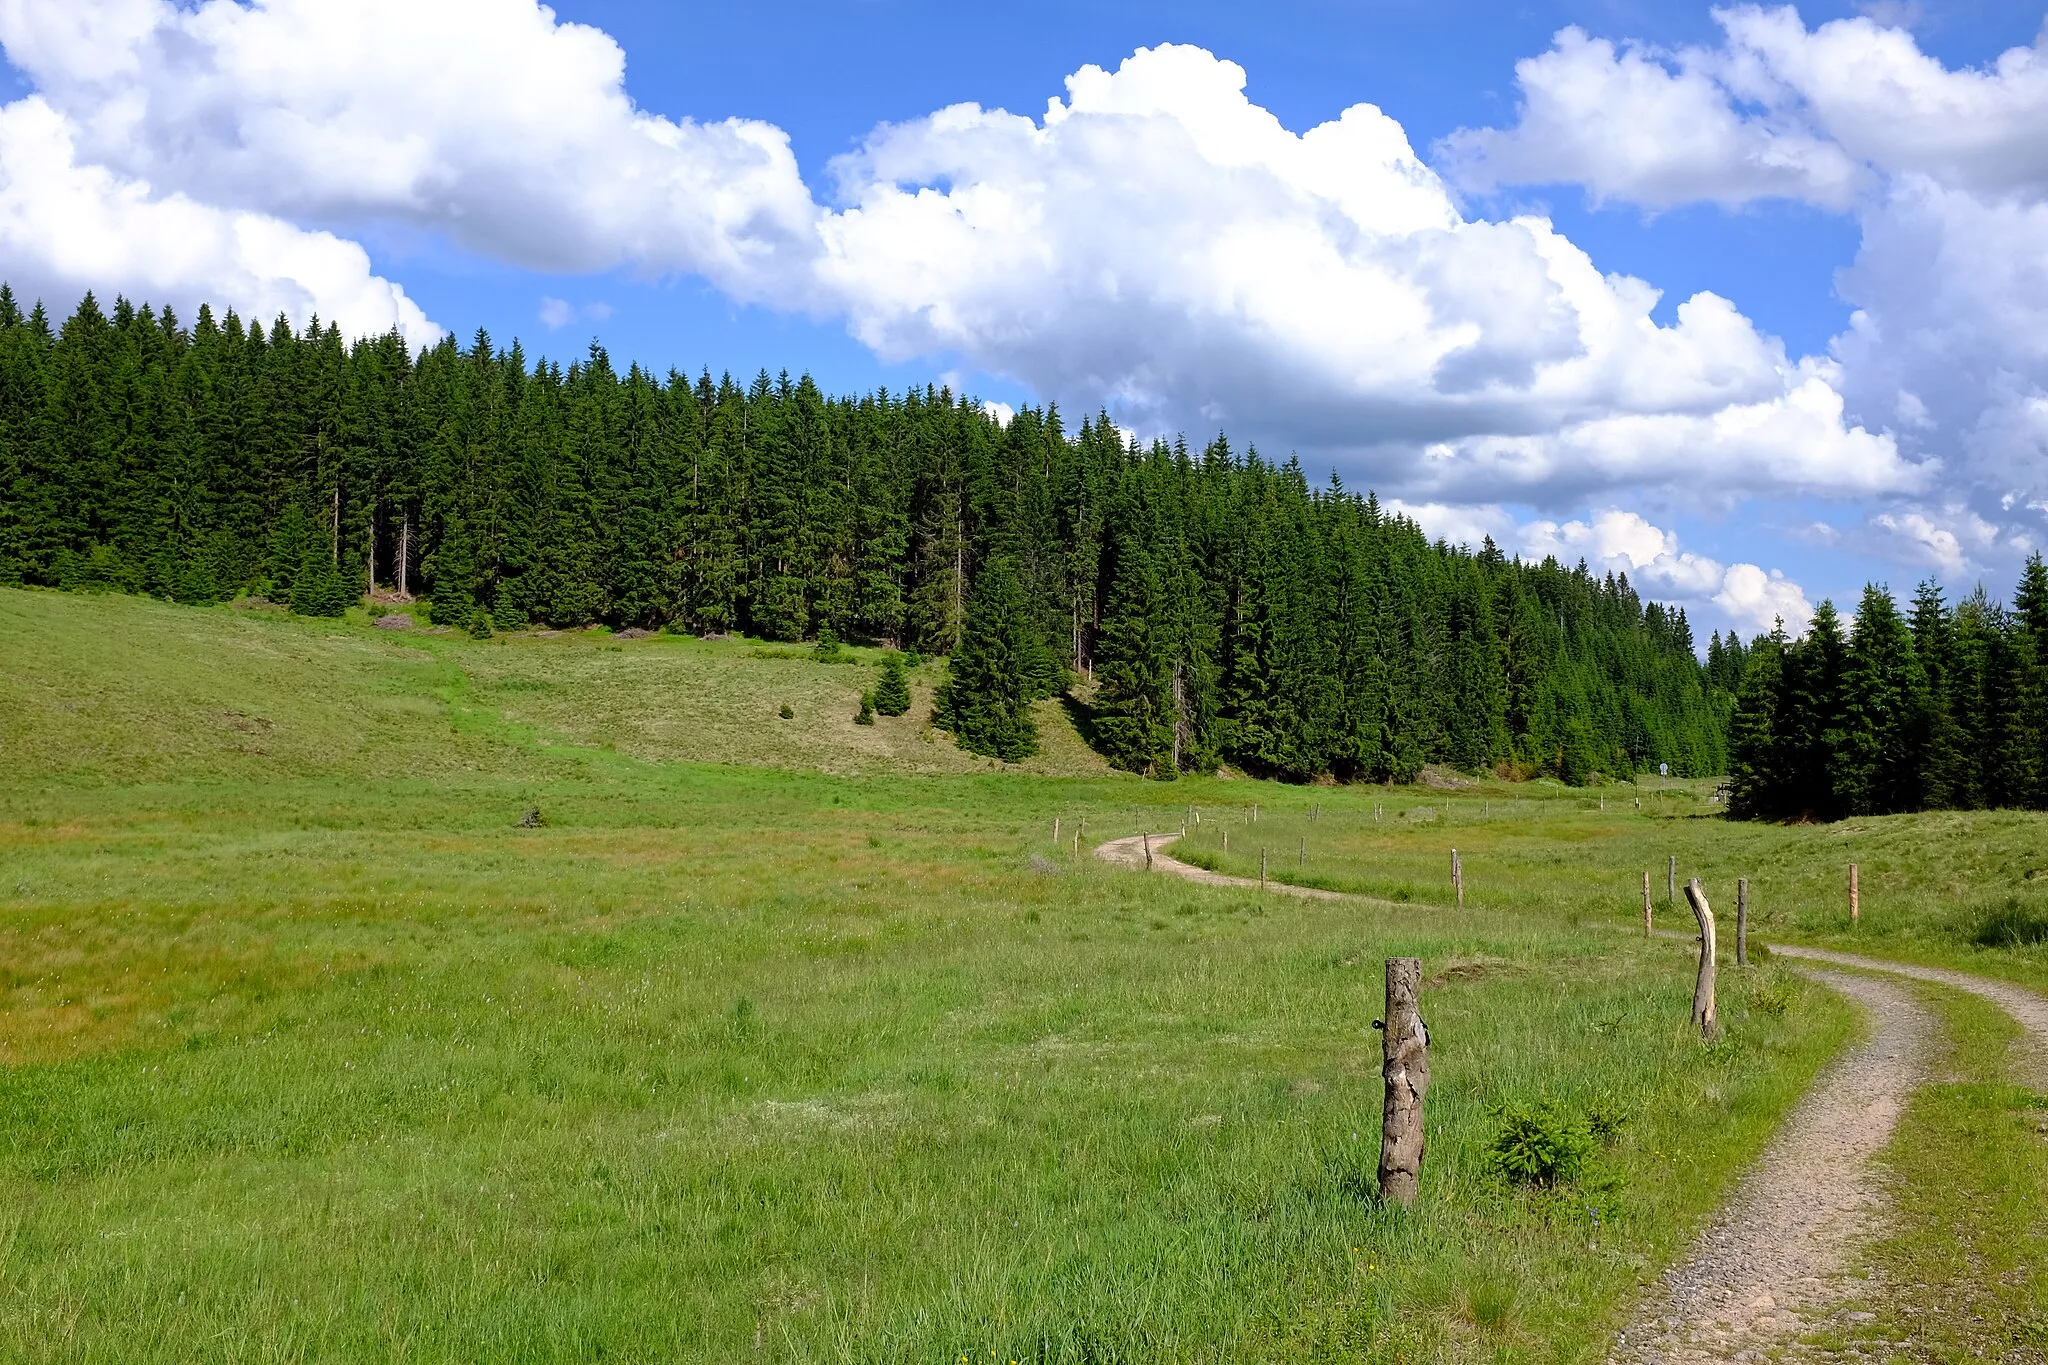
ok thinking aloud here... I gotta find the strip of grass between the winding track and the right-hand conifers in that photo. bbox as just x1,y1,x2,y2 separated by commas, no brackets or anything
1174,778,2048,988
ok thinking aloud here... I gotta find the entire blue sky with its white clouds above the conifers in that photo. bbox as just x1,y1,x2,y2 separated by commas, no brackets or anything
0,0,2048,632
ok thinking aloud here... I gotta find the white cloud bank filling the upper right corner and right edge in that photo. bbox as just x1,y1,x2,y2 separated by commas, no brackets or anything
1438,6,2048,575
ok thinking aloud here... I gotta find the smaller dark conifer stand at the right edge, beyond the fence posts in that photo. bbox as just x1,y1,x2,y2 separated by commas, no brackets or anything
1731,568,2048,821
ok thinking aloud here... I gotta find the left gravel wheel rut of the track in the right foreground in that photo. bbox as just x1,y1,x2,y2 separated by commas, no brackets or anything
1610,968,1935,1365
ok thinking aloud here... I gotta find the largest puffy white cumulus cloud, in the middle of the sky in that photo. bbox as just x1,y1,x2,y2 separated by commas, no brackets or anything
819,47,1900,499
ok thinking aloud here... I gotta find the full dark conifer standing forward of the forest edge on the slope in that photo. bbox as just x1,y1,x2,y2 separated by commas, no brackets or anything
934,559,1038,763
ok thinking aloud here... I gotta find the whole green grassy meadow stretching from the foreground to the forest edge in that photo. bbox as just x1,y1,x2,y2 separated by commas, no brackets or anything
0,589,2048,1363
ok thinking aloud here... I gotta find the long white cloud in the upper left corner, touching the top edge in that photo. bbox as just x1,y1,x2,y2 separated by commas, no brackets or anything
0,0,817,305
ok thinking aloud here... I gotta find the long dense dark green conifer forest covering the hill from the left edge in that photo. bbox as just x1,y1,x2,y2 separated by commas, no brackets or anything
0,291,1741,782
